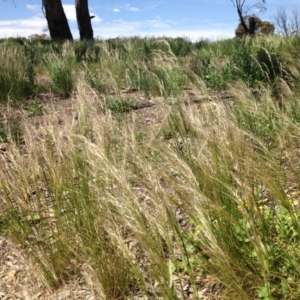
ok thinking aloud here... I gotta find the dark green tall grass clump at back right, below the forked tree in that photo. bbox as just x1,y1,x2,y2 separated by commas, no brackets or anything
191,37,299,94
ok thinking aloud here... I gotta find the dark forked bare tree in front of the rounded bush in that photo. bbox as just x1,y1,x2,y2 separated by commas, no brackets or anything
231,0,266,35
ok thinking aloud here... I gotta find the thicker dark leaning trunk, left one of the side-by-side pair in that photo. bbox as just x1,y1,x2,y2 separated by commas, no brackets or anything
43,0,73,40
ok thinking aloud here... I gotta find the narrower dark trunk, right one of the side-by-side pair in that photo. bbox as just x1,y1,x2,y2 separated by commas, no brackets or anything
76,0,94,40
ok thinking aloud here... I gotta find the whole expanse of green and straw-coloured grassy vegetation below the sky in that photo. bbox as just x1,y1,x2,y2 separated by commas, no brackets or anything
0,36,300,300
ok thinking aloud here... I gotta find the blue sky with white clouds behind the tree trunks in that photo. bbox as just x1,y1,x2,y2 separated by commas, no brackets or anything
0,0,300,41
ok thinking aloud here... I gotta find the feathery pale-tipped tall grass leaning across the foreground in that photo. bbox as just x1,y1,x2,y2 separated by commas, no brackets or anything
1,78,299,299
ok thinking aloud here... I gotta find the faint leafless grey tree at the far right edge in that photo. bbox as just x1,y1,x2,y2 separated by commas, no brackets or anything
273,7,300,36
